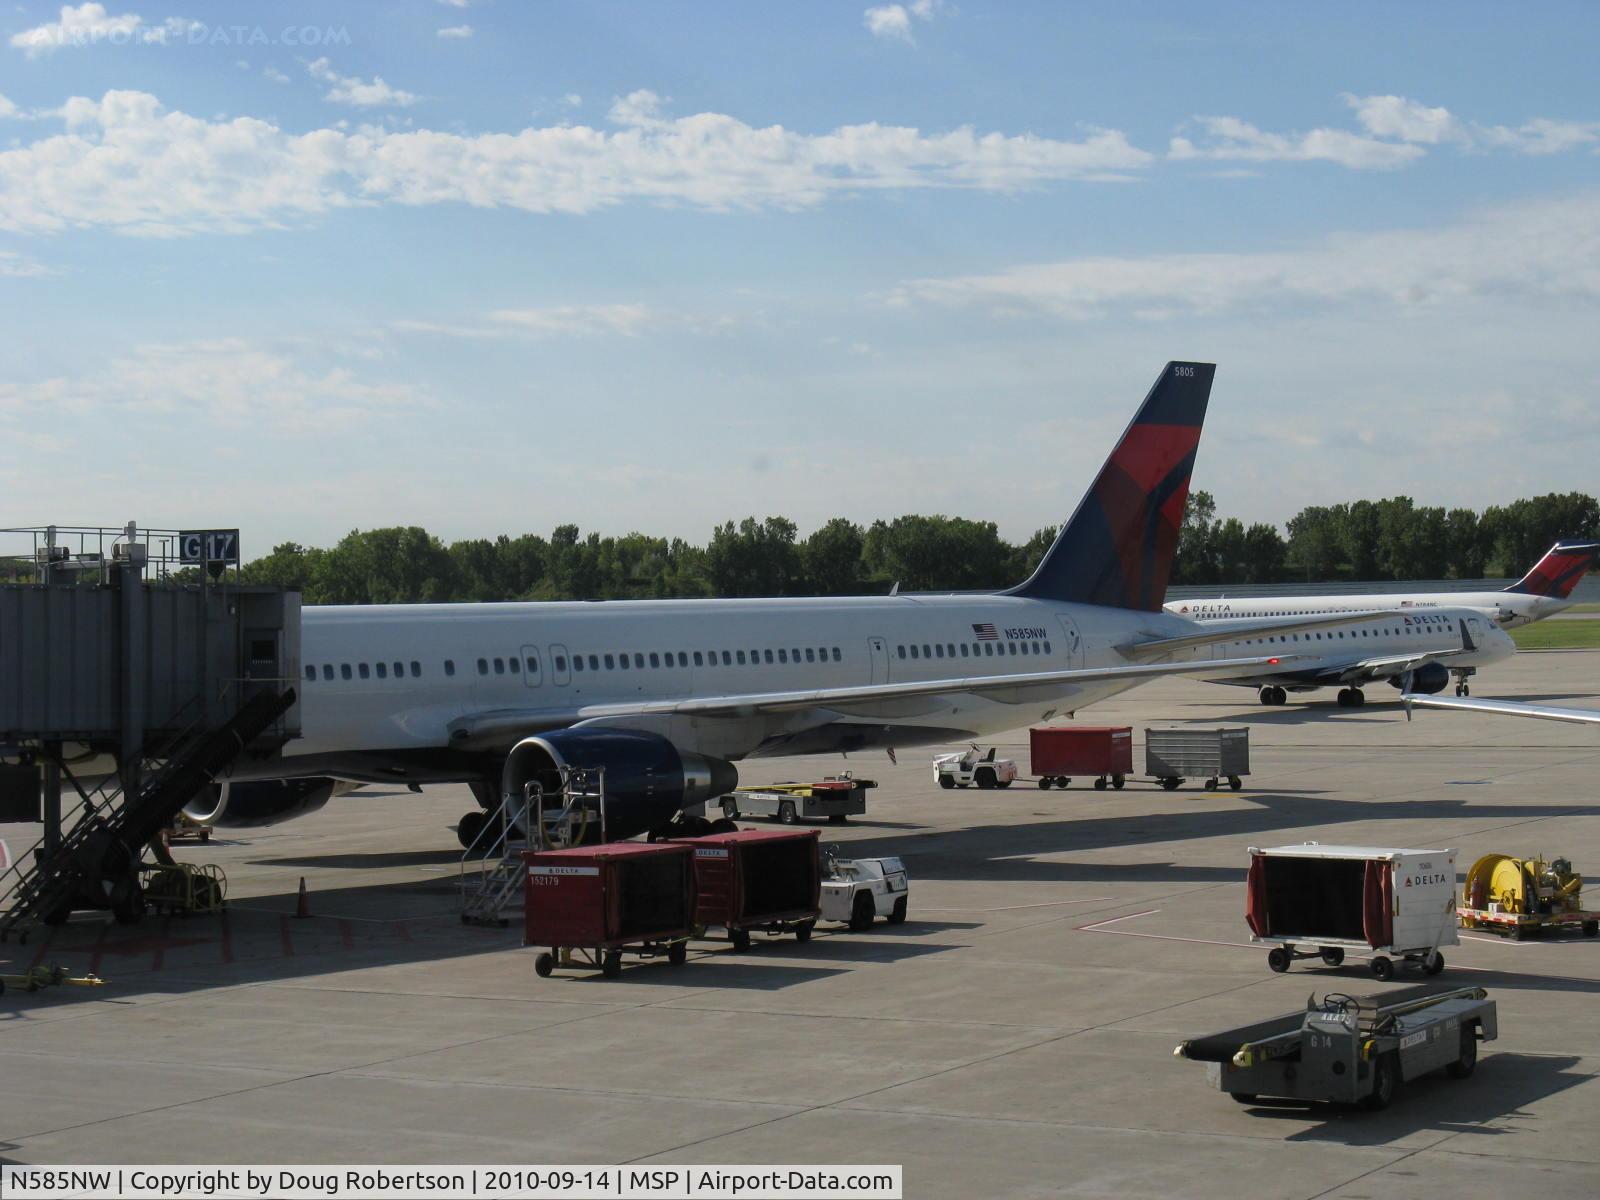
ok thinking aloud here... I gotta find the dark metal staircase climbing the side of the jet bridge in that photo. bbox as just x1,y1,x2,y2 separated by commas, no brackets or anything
0,688,294,942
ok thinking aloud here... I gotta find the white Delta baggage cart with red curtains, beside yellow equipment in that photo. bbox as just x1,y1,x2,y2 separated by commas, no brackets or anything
1245,842,1461,979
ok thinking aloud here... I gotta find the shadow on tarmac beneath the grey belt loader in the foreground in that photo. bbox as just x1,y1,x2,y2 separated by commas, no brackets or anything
1250,1045,1592,1154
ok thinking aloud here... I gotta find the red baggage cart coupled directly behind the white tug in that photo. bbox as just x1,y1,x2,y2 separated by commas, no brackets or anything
688,829,822,952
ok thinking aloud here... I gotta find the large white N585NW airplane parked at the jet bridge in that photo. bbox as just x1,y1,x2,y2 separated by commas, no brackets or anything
186,362,1465,845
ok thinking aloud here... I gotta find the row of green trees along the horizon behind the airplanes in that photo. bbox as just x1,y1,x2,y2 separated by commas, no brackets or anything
240,491,1600,605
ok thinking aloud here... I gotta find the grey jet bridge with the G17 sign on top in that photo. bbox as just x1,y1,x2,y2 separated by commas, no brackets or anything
0,525,301,939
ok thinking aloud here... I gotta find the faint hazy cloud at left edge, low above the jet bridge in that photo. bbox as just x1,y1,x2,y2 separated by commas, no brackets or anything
0,338,432,435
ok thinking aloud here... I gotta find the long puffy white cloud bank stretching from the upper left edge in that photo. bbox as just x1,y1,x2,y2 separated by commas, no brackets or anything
0,87,1150,237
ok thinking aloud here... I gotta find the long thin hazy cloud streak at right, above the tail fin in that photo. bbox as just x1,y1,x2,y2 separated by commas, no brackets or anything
890,192,1600,320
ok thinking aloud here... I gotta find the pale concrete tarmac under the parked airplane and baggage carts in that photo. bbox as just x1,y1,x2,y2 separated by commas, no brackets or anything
0,651,1600,1200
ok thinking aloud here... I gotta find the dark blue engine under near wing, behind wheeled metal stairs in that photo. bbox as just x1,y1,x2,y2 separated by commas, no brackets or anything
501,726,739,840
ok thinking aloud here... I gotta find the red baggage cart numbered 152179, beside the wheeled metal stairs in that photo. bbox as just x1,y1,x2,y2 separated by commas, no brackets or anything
522,842,694,978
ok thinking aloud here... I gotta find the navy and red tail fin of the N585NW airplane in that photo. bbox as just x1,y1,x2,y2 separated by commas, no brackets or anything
1006,363,1216,613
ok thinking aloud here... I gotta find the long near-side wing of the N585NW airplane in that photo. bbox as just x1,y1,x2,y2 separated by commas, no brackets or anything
450,656,1288,746
